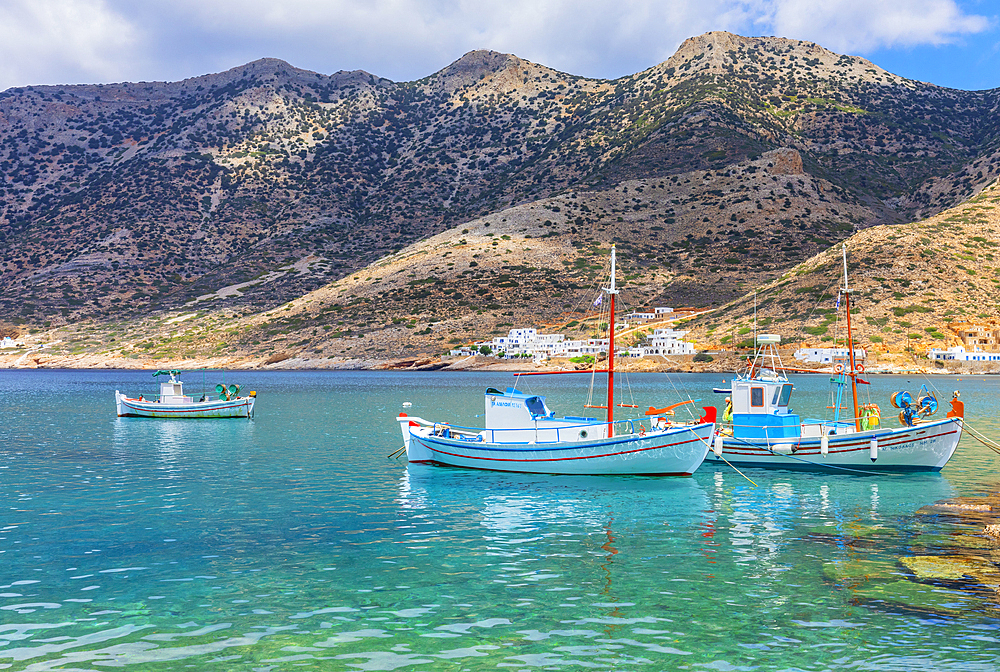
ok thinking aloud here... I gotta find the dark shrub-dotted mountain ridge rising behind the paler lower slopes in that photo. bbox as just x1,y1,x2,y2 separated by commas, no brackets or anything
0,33,1000,364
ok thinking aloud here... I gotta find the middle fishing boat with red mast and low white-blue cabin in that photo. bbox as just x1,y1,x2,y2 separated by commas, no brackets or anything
397,247,716,476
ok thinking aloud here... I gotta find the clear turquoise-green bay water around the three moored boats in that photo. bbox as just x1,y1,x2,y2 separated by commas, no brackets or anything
0,371,1000,670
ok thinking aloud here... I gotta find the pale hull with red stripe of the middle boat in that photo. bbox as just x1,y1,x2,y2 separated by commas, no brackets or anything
404,423,715,476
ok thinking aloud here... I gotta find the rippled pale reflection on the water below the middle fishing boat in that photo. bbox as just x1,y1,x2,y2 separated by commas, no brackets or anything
397,464,715,600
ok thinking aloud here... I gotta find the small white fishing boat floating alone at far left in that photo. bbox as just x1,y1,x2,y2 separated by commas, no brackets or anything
115,370,257,418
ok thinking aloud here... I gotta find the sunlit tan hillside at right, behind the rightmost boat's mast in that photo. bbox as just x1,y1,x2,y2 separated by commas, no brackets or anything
690,177,1000,357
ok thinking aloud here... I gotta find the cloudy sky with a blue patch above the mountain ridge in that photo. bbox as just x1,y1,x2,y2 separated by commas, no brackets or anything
0,0,1000,91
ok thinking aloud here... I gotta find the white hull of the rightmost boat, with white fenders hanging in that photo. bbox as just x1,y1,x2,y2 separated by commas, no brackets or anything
706,418,962,473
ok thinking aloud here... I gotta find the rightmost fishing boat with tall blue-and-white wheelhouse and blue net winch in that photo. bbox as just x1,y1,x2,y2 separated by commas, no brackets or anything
707,246,964,473
